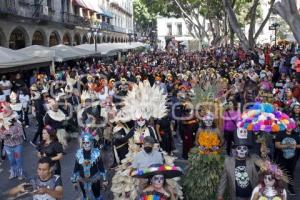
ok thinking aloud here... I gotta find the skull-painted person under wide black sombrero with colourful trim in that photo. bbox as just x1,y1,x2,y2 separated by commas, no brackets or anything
131,164,182,200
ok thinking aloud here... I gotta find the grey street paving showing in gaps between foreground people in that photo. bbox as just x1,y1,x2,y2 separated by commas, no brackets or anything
0,119,300,200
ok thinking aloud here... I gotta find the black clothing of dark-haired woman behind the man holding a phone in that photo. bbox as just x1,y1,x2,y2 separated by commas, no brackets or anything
37,141,63,175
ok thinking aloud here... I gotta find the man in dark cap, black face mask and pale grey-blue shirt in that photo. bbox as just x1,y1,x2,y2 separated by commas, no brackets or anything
132,136,164,169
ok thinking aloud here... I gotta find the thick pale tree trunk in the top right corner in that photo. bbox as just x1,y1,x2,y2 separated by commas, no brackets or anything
274,0,300,44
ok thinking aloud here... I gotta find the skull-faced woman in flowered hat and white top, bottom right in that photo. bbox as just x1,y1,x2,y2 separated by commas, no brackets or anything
251,161,288,200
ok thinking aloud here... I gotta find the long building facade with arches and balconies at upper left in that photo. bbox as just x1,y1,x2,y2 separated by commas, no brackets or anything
0,0,133,49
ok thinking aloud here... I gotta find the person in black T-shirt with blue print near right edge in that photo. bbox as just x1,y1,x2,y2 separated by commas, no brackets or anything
275,128,300,195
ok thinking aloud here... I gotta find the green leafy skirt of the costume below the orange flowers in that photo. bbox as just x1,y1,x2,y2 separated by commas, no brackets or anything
183,147,224,200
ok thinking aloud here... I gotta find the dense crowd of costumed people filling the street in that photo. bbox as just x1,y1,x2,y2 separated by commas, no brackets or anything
0,41,300,200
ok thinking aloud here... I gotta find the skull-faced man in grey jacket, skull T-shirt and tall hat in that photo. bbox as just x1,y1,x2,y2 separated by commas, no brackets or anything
217,131,258,200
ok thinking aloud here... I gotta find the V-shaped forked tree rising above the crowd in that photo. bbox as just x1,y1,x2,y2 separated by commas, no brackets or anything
222,0,275,49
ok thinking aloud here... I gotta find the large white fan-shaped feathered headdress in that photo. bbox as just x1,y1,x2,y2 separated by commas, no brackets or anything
116,81,167,122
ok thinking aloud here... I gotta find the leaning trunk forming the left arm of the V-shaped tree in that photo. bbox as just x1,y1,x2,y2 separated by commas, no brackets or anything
223,0,250,50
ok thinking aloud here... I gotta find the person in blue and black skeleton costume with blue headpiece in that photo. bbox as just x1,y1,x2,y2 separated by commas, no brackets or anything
72,133,108,200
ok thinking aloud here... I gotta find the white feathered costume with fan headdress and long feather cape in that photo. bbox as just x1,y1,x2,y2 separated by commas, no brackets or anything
112,81,182,200
